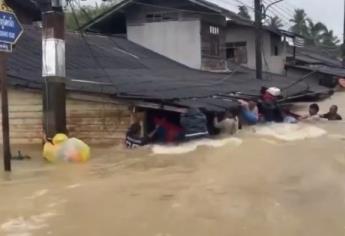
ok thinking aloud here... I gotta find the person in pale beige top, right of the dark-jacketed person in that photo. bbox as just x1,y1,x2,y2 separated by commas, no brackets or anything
214,111,238,136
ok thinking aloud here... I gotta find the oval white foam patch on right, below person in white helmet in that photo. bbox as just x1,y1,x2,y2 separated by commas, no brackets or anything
255,123,327,141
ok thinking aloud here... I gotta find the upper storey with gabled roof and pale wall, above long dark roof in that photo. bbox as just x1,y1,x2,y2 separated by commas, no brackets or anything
82,0,250,71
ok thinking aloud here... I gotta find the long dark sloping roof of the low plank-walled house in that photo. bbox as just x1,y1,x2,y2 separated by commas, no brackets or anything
8,26,326,111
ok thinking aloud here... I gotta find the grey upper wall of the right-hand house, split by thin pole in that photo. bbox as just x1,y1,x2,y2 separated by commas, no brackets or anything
226,27,286,74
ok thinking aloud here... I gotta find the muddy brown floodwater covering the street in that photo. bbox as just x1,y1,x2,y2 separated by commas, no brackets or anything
0,93,345,236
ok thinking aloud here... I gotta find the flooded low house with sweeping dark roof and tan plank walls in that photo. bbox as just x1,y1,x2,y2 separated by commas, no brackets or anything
0,0,328,144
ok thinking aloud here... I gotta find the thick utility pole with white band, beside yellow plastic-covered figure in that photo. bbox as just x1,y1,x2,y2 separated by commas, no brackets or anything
42,0,67,138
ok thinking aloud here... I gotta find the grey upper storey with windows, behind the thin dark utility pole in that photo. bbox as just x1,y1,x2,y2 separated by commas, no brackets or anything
225,20,287,74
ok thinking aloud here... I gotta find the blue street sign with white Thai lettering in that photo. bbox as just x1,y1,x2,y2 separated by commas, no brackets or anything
0,11,23,44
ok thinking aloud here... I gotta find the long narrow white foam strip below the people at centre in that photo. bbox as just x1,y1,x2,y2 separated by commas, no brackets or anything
152,137,242,155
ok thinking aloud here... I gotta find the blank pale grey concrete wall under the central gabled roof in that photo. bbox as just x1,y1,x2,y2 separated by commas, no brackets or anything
127,20,201,69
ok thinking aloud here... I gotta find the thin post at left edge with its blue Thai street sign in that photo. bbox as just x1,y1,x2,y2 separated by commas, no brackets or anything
0,2,23,171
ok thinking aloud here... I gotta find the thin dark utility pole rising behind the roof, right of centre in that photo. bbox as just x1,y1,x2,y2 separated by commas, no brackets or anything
254,0,262,80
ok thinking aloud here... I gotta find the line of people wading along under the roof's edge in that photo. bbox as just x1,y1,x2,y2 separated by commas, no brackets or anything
125,88,342,148
